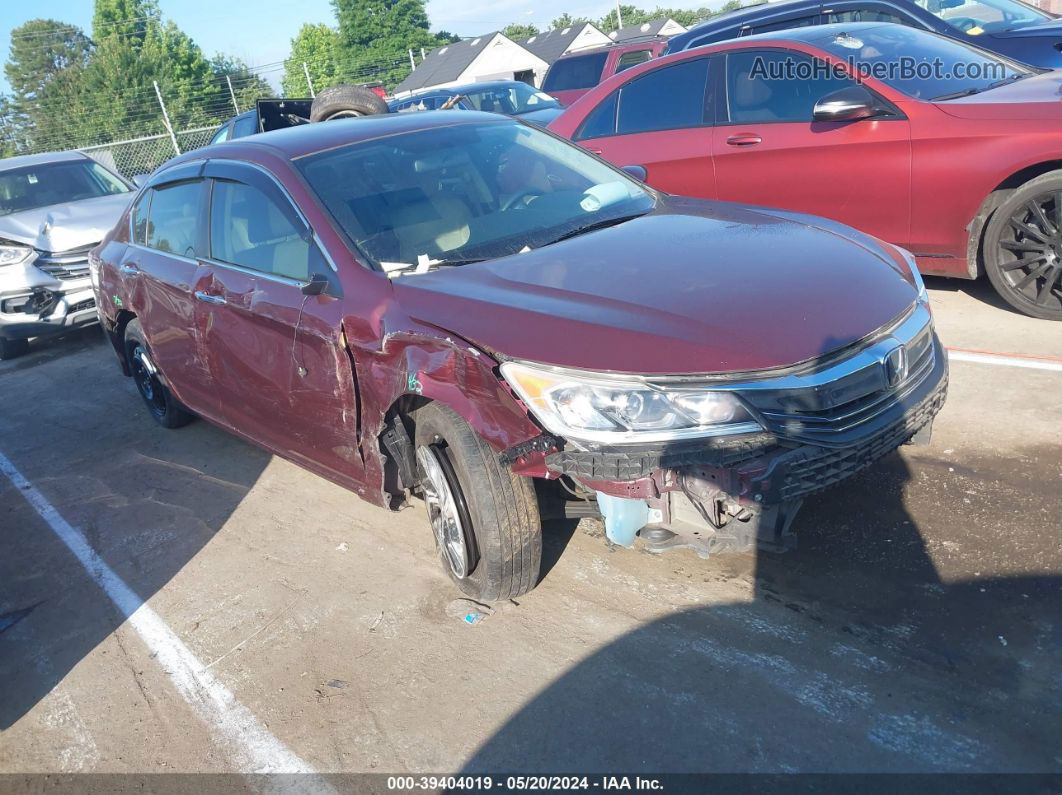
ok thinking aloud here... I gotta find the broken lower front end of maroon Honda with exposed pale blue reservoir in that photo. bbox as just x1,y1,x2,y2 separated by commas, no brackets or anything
546,349,947,556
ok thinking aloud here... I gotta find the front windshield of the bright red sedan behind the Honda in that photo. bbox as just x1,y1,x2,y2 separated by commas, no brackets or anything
816,24,1032,100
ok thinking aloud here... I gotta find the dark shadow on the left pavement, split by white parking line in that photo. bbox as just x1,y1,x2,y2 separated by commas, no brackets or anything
0,343,271,731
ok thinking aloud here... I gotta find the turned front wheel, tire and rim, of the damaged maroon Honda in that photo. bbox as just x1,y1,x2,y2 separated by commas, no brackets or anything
415,403,542,602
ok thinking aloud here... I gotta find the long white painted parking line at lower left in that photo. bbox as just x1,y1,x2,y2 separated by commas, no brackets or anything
0,453,331,792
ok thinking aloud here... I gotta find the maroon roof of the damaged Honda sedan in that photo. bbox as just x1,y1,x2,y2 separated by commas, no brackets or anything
190,110,520,162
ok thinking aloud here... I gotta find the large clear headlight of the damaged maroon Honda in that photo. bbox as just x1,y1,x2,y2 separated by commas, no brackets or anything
501,362,763,445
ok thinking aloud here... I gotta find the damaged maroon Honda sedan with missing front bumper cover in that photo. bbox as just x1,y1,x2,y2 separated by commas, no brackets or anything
92,111,946,600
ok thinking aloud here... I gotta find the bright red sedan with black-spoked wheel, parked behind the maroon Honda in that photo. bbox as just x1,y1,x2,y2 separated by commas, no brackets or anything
550,23,1062,321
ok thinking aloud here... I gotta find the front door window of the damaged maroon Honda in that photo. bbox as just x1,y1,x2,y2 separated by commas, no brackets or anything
210,179,327,281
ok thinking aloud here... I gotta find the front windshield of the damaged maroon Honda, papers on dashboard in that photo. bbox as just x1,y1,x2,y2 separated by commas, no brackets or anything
296,121,655,272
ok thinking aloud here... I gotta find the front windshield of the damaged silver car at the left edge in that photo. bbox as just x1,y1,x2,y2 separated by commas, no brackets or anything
0,160,130,215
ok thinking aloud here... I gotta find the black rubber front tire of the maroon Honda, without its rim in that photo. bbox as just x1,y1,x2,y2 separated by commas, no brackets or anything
415,403,542,602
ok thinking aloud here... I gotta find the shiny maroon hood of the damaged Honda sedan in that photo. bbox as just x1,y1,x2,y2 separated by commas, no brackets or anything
394,198,917,375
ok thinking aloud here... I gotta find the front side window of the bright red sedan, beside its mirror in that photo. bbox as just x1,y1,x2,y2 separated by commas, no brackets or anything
726,50,857,124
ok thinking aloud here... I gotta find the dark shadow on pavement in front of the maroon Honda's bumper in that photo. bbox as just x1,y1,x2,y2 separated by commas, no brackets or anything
461,331,1062,772
